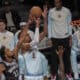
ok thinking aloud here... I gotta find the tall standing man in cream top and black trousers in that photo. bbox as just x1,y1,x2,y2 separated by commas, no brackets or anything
48,0,72,80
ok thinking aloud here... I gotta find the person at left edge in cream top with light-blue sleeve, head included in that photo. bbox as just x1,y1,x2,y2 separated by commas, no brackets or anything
0,18,14,50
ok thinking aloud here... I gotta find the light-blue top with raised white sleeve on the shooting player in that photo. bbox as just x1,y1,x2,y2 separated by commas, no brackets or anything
18,28,47,80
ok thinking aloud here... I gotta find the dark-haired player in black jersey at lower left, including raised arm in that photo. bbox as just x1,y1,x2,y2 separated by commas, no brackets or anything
0,25,28,80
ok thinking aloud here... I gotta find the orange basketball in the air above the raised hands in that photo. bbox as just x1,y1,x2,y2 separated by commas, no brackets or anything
30,6,42,17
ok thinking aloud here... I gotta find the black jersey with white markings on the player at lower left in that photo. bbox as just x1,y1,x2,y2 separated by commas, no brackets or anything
3,60,19,80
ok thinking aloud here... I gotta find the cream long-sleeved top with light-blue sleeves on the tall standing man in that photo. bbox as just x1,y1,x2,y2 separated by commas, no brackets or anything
48,7,72,38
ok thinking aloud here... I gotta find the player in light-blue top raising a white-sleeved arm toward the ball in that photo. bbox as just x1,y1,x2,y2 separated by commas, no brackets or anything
18,10,47,80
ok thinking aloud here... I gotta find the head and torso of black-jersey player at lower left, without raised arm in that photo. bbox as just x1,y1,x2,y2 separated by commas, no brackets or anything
0,47,19,80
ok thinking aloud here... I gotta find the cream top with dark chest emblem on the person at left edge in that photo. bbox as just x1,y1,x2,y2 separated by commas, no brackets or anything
0,31,14,50
